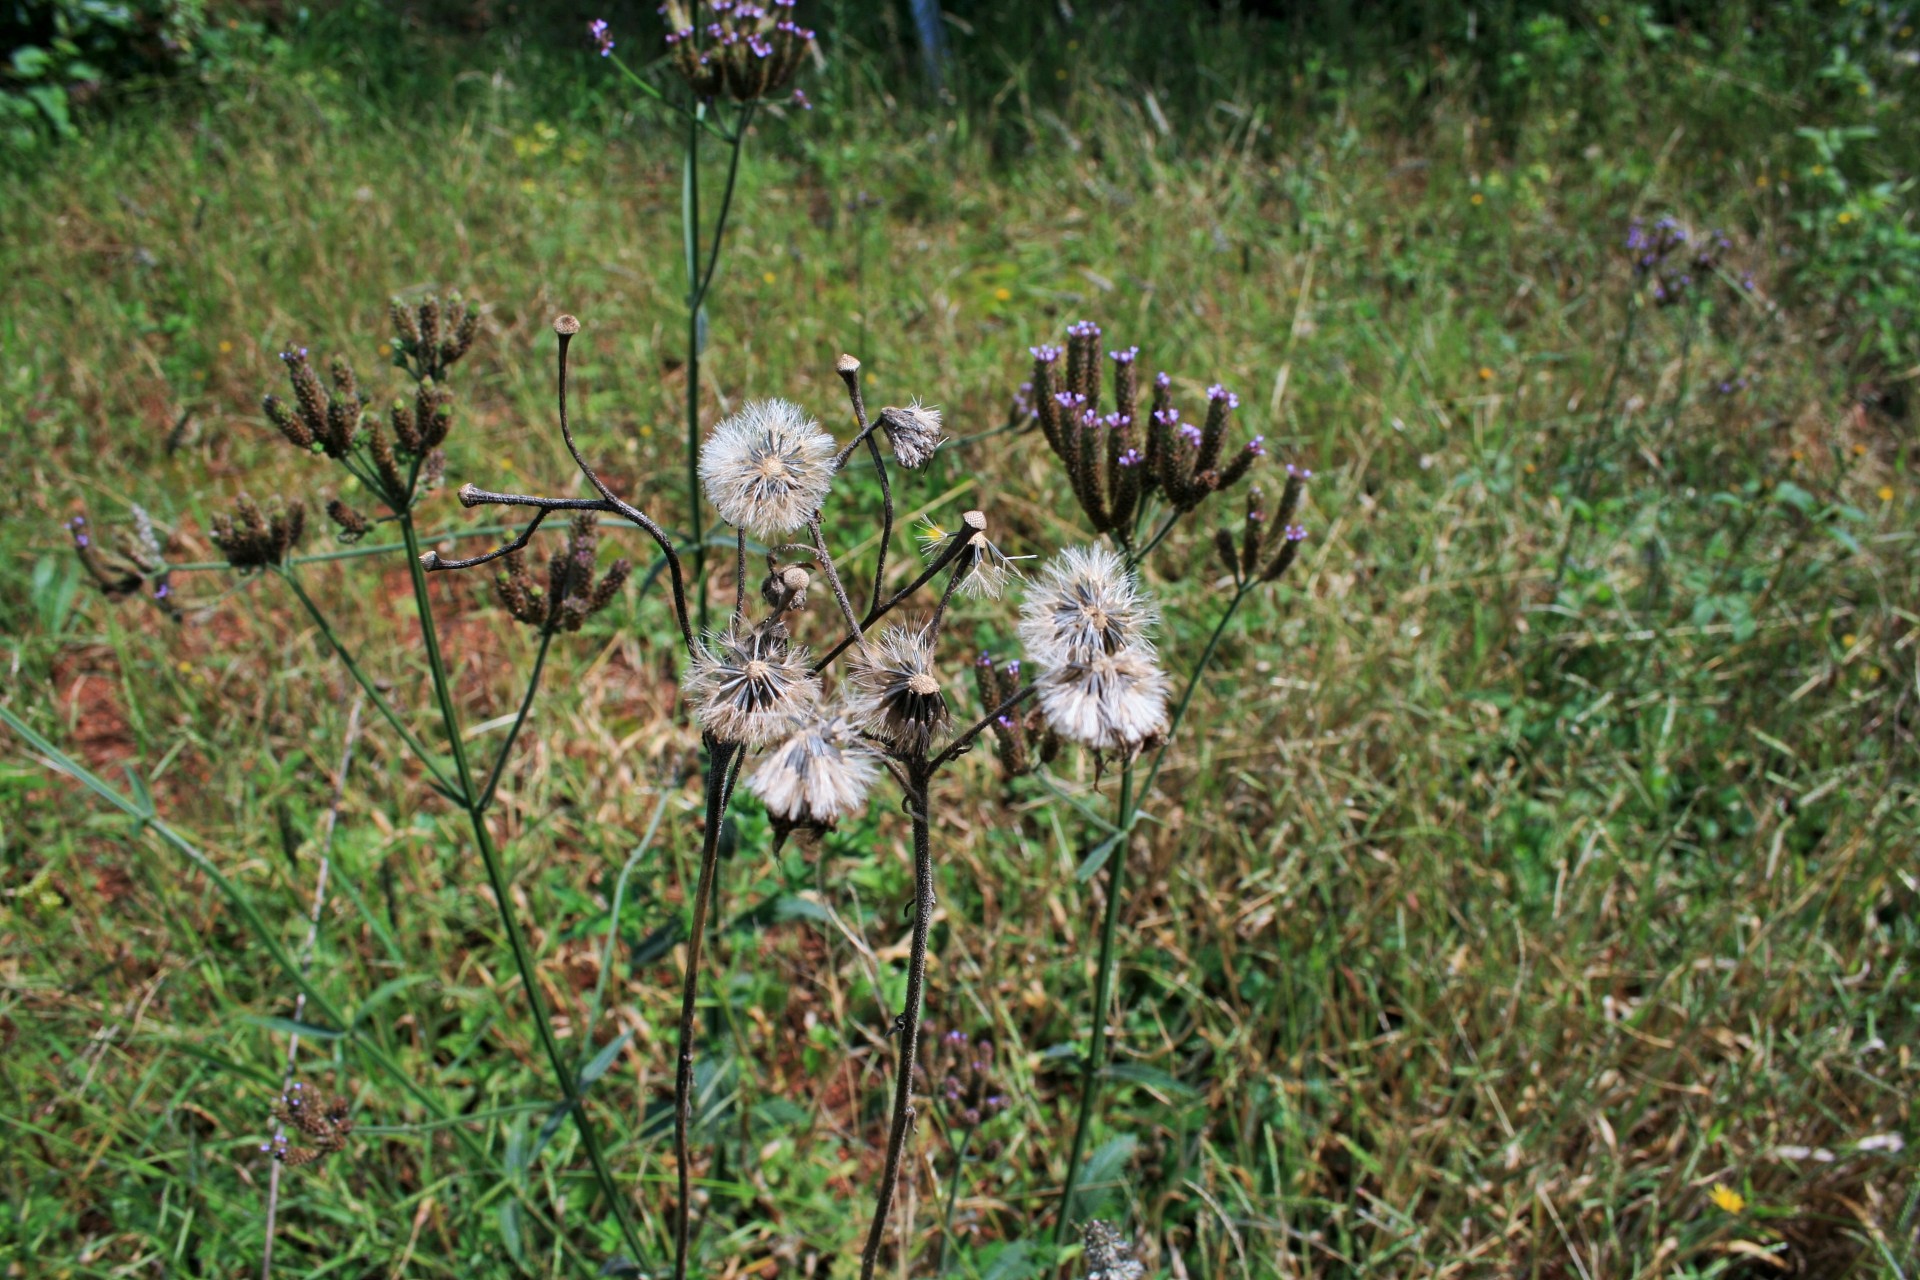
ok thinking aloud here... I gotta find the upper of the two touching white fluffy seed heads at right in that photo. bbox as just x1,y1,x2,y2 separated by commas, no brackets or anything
1020,545,1160,668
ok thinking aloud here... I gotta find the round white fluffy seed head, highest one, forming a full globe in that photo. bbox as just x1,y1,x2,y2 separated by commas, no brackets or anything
701,399,833,537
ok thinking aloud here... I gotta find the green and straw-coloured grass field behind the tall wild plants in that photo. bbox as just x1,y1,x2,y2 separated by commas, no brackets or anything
0,12,1920,1280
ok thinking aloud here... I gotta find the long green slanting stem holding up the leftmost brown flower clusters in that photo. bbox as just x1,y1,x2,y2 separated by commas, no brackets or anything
399,512,641,1259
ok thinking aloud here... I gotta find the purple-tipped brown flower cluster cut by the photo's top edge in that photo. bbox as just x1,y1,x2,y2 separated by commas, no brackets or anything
652,0,814,107
